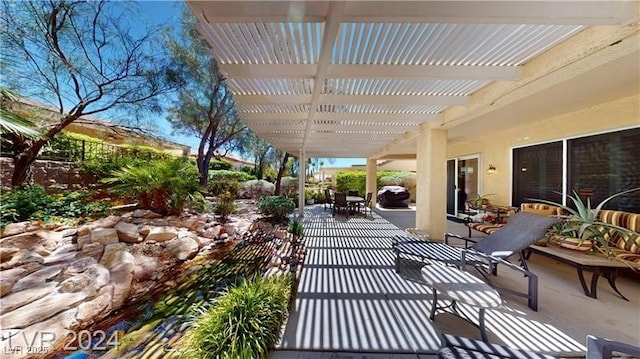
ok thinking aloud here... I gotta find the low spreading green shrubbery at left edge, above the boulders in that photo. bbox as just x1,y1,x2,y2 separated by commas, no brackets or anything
0,185,111,227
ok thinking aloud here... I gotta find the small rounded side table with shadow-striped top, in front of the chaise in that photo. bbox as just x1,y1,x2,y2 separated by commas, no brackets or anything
421,264,502,342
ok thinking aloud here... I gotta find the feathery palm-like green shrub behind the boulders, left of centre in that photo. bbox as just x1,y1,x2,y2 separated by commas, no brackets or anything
102,159,203,214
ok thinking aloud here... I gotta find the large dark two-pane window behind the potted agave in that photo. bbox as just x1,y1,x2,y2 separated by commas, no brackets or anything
512,128,640,213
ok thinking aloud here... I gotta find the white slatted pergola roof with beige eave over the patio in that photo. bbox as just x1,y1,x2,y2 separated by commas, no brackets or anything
187,0,640,219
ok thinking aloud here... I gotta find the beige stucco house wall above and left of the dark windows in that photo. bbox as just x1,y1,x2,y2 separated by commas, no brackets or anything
447,93,640,204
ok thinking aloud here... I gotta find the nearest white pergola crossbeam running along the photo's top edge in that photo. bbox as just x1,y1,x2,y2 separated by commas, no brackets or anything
187,0,639,25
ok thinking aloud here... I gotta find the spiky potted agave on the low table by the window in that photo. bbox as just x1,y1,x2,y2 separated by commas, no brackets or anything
535,187,640,256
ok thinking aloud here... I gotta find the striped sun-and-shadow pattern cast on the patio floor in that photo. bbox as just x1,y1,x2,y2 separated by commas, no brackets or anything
271,205,585,358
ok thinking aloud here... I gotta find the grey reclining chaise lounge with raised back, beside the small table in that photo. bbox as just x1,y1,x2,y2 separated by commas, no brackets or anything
393,212,558,310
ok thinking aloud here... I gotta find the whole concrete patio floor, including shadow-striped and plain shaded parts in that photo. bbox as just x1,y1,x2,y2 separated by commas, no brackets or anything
270,205,640,359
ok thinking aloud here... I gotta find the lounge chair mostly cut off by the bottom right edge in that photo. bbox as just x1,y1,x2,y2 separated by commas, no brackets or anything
438,334,640,359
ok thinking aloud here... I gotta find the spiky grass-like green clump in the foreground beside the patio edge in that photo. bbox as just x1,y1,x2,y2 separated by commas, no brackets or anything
182,276,292,359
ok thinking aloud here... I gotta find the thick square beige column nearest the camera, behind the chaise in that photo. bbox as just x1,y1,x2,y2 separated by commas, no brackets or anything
416,122,447,239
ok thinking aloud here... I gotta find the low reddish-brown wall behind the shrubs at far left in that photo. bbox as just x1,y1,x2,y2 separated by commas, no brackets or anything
0,157,95,189
